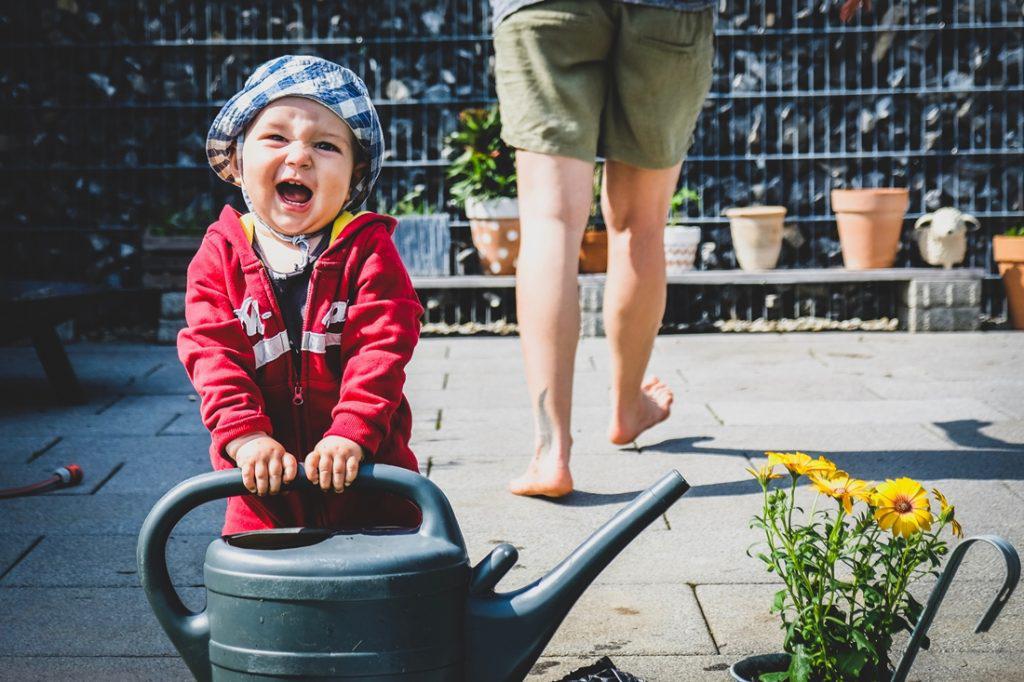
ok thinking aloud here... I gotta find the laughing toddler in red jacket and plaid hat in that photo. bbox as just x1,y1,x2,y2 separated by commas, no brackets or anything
178,56,422,534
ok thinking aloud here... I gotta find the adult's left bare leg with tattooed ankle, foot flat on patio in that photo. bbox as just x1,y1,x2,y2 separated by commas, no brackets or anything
509,151,594,497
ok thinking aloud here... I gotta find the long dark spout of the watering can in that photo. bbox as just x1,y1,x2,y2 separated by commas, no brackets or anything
466,471,689,682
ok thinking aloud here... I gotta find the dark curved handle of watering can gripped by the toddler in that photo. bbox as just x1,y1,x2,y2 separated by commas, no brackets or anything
136,464,465,680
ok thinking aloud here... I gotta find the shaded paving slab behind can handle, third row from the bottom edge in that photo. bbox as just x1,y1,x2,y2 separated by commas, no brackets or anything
0,535,207,588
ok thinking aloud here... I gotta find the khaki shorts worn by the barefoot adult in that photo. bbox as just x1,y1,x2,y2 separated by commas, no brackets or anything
495,0,714,169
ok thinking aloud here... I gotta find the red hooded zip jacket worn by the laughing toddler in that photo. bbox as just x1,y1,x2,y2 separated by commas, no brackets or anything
178,206,423,534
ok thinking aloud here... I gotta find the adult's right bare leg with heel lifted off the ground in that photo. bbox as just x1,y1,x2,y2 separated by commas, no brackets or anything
601,161,681,444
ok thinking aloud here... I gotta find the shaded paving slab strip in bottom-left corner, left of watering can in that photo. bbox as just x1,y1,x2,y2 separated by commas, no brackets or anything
0,655,190,682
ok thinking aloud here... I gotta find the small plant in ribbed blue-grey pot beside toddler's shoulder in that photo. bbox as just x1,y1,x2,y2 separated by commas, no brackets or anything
387,184,452,276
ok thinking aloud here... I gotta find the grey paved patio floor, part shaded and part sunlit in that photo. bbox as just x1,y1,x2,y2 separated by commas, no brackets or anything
0,332,1024,680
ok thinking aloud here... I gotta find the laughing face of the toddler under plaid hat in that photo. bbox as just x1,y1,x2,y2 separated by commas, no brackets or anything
232,97,361,235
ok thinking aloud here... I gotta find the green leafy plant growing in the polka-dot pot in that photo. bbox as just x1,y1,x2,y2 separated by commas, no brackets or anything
444,106,516,206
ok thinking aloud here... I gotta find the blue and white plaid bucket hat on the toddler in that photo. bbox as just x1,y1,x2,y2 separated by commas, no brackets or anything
206,54,384,210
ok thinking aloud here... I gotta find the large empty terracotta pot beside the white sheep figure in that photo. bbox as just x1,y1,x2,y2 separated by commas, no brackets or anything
831,187,910,270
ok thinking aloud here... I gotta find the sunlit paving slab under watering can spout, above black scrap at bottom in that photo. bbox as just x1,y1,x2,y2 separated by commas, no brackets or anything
545,585,715,657
